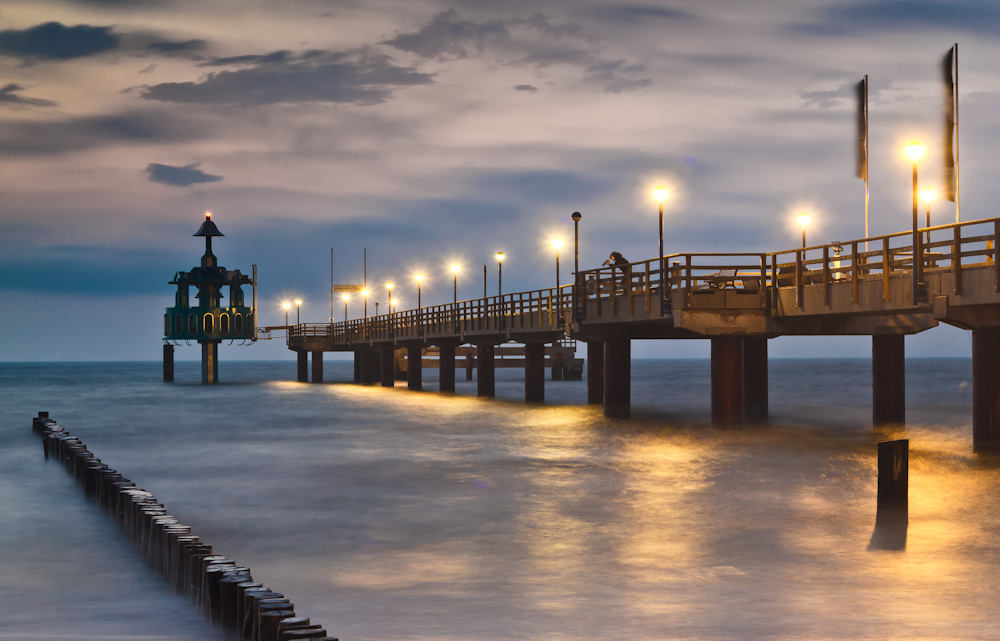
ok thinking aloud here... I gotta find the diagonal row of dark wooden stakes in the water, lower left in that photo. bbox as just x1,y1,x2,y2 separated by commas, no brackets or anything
31,412,336,641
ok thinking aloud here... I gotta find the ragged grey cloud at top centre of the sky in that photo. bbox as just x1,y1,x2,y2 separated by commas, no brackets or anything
382,9,652,93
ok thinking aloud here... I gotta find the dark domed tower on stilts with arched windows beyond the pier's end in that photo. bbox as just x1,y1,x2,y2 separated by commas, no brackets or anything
163,212,257,384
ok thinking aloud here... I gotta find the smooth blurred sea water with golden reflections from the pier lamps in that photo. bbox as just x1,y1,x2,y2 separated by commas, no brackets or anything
0,359,1000,641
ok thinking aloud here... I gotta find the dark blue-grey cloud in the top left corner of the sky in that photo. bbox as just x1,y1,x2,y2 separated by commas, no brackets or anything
0,22,120,61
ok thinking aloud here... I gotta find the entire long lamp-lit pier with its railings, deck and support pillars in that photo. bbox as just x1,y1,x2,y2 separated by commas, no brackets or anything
287,218,1000,451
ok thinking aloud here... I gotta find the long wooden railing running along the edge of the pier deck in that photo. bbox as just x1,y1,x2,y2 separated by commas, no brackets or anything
288,218,1000,346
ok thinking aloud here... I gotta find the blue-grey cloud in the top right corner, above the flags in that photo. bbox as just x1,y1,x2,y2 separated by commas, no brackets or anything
789,0,1000,36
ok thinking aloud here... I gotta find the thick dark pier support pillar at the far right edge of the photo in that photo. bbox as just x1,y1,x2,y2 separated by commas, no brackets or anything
972,327,1000,452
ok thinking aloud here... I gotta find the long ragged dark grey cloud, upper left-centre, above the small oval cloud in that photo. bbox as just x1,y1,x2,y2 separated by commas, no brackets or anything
142,52,433,105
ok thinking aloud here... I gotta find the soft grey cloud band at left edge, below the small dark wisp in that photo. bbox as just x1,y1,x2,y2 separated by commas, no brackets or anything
0,112,202,156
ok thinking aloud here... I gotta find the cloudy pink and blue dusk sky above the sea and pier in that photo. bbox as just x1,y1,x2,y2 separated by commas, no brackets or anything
0,0,1000,361
